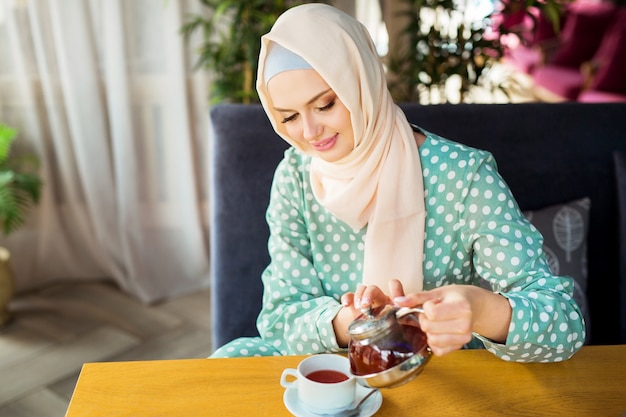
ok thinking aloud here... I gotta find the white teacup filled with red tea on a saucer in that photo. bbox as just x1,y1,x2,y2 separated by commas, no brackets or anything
280,353,356,413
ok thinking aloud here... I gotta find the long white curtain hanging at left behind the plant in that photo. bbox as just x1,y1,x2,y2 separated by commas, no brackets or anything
0,0,209,302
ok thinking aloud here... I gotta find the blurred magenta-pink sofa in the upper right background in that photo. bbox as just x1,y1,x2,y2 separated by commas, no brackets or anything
505,0,626,102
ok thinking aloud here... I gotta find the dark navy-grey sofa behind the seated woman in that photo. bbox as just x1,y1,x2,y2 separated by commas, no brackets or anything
210,103,626,349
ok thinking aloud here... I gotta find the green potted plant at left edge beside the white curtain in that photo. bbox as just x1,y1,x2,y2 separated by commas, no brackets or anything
0,124,43,326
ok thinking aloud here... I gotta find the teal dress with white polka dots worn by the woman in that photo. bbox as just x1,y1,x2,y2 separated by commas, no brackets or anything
212,133,585,362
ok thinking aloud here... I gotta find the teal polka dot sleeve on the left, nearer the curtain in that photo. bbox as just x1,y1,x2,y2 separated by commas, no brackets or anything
257,150,341,355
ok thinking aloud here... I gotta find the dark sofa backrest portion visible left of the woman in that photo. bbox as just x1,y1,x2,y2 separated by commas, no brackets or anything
209,104,288,349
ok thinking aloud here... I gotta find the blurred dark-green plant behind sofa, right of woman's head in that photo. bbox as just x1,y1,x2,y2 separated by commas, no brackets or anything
388,0,571,102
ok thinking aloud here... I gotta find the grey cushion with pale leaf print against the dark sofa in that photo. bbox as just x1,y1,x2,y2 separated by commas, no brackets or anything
524,197,591,342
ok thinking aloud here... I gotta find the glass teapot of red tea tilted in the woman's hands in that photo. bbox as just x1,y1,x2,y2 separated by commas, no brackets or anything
348,305,431,388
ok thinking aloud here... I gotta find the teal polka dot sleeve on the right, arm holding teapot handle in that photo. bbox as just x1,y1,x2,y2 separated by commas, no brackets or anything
461,151,585,362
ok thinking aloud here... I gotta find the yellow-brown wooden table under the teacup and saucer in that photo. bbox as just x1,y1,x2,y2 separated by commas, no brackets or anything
66,345,626,417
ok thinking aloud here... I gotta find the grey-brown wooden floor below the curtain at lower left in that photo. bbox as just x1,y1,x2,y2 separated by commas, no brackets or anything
0,283,211,417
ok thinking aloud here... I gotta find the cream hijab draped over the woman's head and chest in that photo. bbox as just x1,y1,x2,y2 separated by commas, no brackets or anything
257,3,426,292
